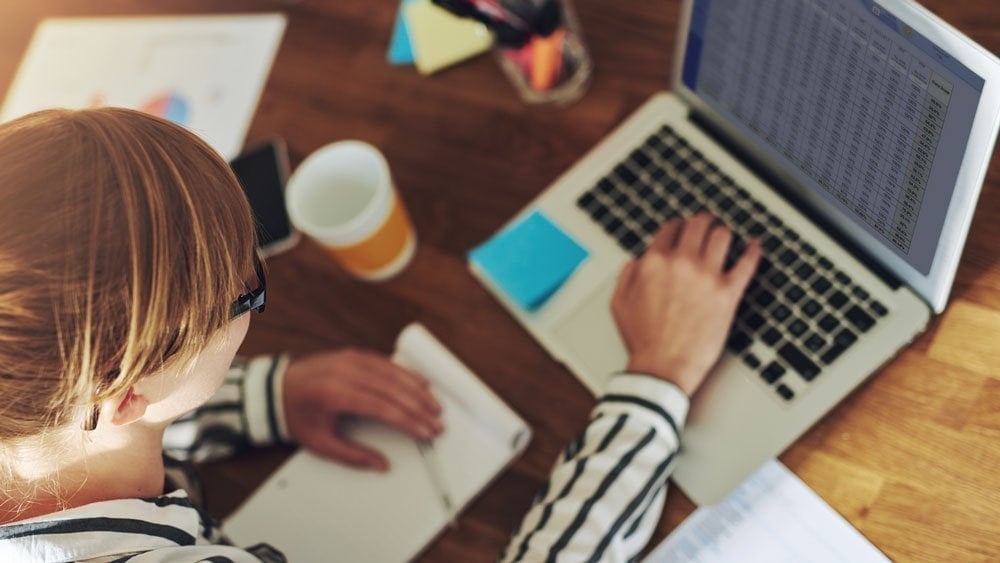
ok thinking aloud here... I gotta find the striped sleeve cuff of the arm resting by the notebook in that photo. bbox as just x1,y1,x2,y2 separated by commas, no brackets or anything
163,355,291,462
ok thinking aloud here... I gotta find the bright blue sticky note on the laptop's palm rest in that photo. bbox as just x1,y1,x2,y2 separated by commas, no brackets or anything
469,211,590,311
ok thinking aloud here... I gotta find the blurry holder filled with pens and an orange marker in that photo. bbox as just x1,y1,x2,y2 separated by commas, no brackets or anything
433,0,593,105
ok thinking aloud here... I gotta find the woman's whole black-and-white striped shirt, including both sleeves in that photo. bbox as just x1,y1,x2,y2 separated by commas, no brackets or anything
0,356,688,563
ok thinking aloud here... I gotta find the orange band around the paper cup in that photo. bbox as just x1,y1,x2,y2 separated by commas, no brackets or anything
324,196,413,275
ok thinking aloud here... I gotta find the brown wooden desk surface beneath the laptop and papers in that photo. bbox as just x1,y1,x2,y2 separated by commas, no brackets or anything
0,0,1000,561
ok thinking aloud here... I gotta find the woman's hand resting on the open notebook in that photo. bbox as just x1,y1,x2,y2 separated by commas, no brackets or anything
284,349,443,471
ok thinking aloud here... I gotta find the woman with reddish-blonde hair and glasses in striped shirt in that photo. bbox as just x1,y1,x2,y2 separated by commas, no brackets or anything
0,109,759,561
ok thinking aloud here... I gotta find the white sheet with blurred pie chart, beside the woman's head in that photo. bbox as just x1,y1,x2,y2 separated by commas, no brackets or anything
0,14,285,159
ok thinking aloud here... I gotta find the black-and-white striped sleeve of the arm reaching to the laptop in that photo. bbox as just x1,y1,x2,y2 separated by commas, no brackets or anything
501,374,688,561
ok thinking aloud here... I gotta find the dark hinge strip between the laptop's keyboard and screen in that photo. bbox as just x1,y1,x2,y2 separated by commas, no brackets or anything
688,110,903,290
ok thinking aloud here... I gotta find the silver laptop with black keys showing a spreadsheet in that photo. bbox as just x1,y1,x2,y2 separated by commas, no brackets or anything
473,0,1000,504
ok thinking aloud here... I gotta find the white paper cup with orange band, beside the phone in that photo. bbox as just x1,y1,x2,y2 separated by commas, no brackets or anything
285,141,417,281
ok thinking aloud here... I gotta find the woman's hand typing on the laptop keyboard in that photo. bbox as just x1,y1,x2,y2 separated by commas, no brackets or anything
611,213,761,396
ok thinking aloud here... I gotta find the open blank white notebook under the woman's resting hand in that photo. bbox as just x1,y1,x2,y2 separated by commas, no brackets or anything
224,324,531,562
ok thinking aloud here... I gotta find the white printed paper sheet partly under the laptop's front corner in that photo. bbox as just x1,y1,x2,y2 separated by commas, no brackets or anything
646,460,889,563
